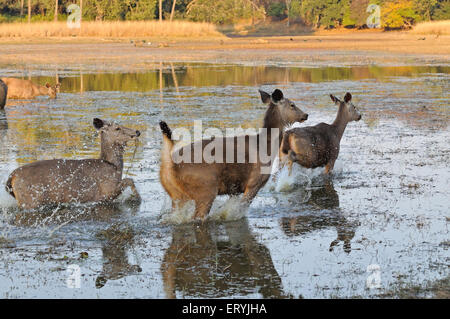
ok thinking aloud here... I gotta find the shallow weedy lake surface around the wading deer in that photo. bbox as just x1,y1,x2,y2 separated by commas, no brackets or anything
0,63,450,298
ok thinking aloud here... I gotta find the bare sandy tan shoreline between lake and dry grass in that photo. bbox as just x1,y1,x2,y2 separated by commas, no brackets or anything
0,32,450,70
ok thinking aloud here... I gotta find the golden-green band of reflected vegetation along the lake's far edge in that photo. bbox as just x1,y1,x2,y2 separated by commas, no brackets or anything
8,63,450,94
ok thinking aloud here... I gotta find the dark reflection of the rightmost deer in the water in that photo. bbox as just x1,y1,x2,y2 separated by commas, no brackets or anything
281,181,358,253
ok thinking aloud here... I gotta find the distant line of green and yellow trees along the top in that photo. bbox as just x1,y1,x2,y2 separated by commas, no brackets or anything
0,0,450,29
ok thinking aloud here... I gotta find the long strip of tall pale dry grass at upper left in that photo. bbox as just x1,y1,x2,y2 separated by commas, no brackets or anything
0,21,222,38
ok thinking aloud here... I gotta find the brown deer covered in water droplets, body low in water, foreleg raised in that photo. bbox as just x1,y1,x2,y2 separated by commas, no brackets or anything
6,118,140,209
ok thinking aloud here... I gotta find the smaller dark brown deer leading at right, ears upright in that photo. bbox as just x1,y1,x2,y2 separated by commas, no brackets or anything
280,92,361,174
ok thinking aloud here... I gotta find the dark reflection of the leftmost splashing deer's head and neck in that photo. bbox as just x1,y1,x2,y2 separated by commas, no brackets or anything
95,224,142,288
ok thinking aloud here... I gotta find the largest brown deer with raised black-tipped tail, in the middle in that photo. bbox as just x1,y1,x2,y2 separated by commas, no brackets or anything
160,89,308,219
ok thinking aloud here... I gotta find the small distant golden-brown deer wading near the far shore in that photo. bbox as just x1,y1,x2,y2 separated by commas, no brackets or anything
1,78,61,99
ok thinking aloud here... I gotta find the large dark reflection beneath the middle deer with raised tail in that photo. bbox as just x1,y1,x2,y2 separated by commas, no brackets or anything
161,219,285,298
